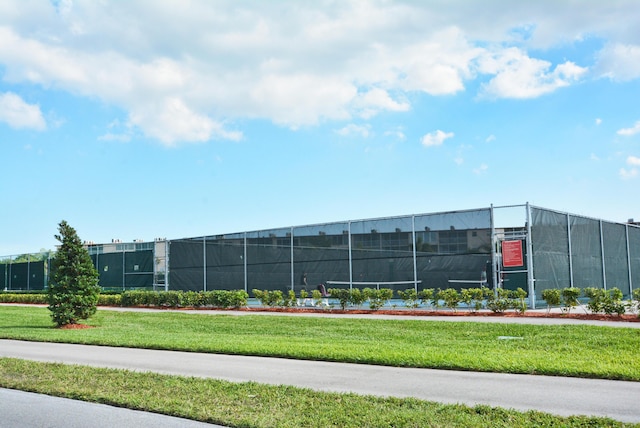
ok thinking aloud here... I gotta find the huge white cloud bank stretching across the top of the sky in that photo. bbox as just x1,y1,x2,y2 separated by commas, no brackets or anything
0,0,640,145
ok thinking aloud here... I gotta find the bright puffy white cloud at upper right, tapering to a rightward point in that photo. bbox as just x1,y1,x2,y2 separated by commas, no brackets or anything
479,48,587,99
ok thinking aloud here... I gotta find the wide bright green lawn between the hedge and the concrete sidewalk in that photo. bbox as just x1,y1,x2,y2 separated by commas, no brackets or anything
0,306,640,381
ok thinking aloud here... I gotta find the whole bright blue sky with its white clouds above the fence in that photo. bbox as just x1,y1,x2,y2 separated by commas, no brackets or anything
0,0,640,255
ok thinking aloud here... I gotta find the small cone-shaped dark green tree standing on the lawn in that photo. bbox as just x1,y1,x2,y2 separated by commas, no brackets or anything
47,220,100,327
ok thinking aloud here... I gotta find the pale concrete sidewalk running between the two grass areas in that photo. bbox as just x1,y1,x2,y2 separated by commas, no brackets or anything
0,340,640,423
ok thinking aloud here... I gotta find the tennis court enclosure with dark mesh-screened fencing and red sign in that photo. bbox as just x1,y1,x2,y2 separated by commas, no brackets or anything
0,204,640,308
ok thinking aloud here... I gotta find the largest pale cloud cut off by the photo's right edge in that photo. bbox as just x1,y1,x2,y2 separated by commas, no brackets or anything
596,43,640,82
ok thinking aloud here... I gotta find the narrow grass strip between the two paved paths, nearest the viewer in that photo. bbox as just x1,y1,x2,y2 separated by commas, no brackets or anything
0,358,640,427
